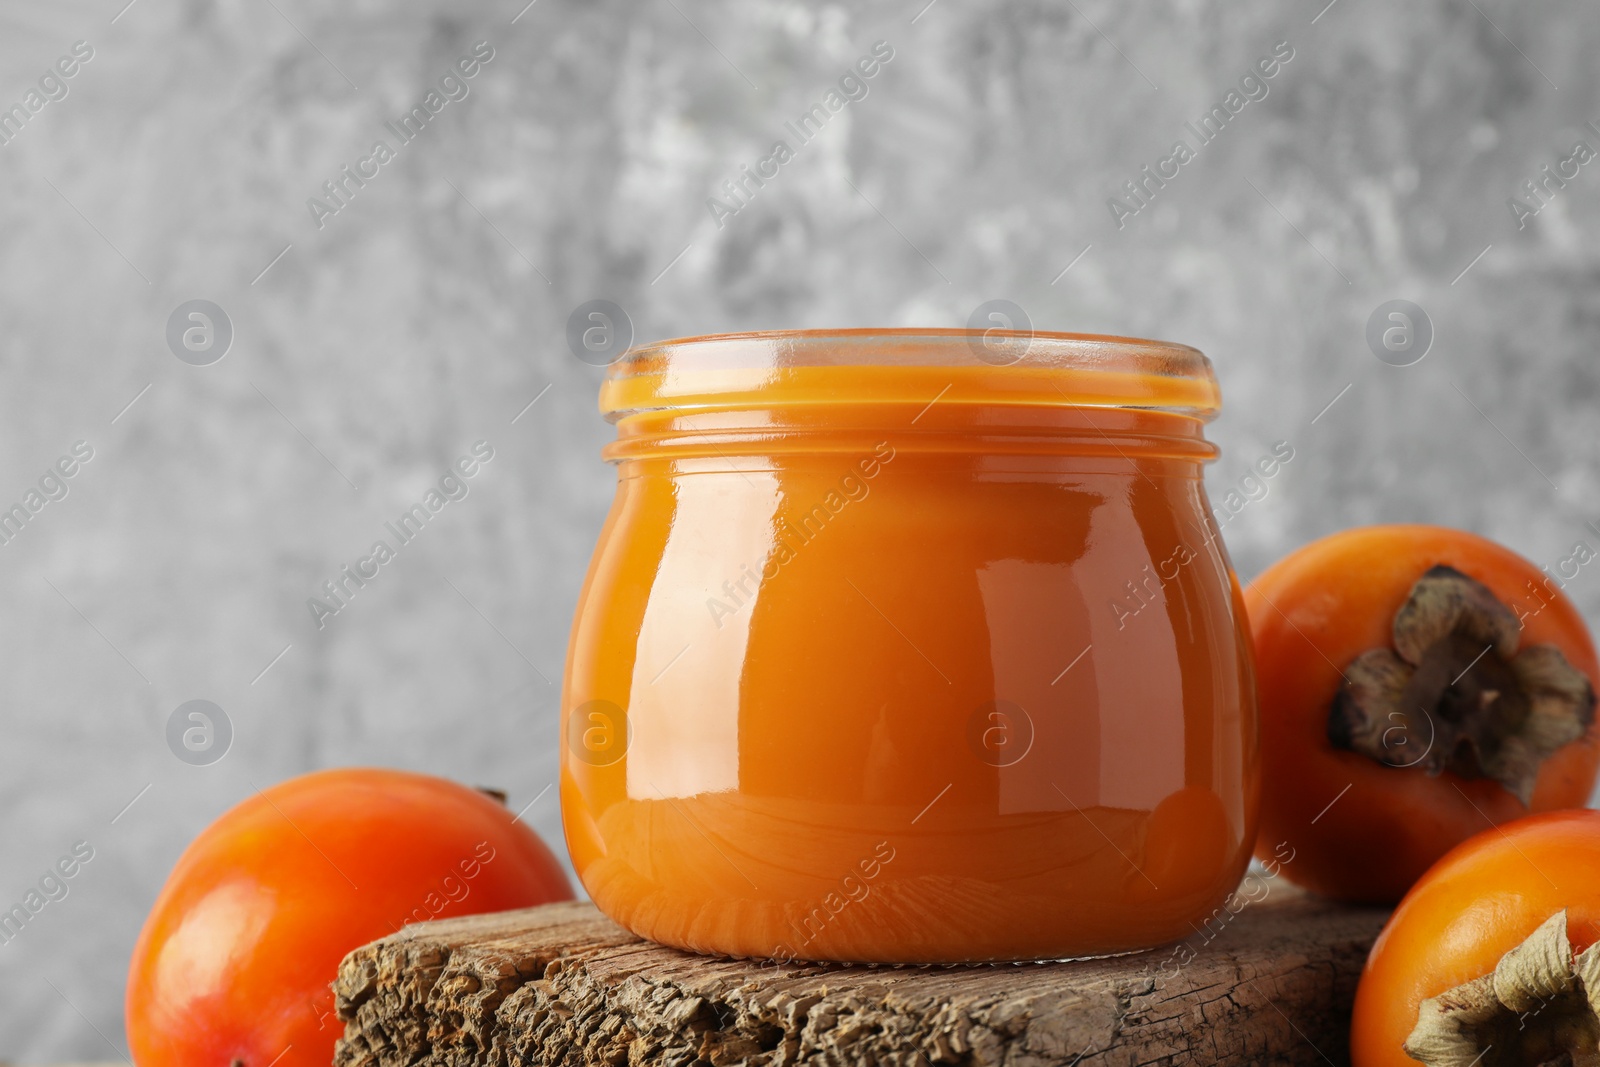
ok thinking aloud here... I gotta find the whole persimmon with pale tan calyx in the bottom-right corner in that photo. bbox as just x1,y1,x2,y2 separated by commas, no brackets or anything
1350,811,1600,1067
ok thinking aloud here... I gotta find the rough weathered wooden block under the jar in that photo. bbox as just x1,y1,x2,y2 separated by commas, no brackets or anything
334,885,1384,1067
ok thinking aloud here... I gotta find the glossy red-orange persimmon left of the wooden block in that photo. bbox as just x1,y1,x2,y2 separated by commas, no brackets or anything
126,768,573,1067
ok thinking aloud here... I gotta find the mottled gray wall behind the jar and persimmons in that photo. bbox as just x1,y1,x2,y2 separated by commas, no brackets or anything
0,0,1600,1062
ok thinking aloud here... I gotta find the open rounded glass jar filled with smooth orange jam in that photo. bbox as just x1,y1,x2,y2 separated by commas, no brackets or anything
562,330,1258,963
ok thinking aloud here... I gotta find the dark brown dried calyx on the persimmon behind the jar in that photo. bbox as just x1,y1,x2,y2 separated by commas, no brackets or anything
1328,566,1595,805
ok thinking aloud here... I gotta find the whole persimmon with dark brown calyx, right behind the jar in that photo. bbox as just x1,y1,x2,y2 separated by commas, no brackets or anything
1245,526,1600,904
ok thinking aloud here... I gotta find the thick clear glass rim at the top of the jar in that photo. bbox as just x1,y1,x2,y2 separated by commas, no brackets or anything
600,326,1221,421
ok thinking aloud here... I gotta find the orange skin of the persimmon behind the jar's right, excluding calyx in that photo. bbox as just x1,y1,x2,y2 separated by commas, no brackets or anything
1245,526,1600,904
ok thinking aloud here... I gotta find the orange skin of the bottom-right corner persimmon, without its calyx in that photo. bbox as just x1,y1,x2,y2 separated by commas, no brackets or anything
1350,811,1600,1067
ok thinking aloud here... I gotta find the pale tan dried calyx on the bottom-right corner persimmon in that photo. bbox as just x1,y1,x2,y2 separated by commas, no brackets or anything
1405,912,1600,1067
